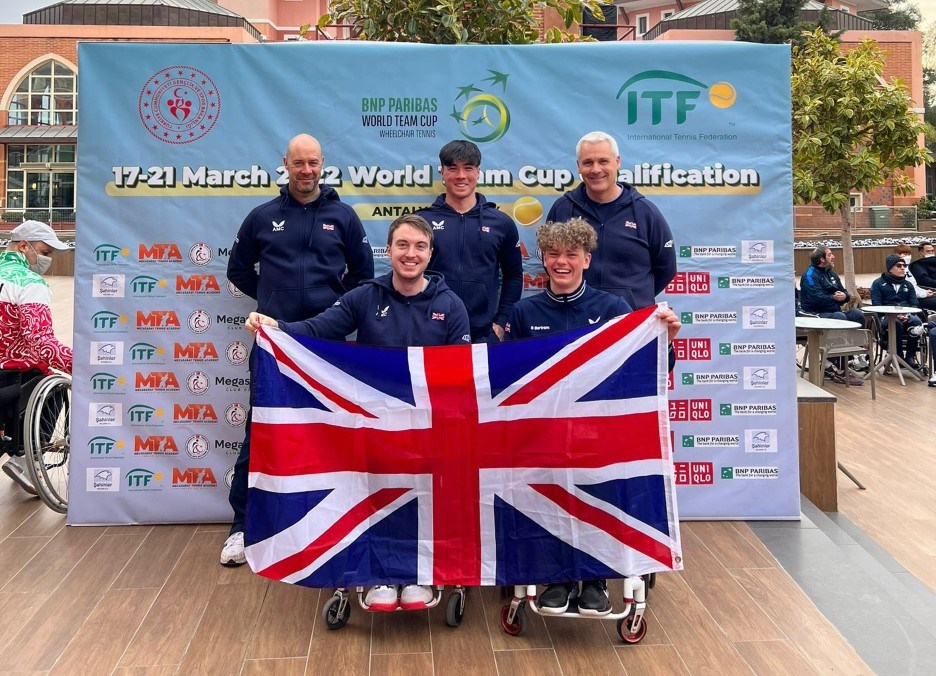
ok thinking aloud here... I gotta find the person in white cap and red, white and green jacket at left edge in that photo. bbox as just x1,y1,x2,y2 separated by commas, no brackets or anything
0,221,72,495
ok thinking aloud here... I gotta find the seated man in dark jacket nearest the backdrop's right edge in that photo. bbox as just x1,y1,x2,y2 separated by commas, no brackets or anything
800,247,864,385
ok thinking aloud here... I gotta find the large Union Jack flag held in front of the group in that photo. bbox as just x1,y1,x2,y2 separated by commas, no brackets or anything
246,307,682,587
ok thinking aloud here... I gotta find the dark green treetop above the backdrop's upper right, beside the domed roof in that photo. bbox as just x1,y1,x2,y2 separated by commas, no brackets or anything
731,0,829,45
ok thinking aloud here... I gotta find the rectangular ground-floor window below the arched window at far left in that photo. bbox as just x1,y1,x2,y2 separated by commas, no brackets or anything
6,144,75,215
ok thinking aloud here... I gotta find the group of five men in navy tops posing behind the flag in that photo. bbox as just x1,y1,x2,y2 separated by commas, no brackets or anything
221,132,680,615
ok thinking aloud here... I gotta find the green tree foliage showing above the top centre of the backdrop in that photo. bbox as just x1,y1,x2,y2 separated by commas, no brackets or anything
302,0,602,45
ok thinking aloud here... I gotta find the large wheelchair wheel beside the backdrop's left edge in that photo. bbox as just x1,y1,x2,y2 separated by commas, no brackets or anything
23,374,71,514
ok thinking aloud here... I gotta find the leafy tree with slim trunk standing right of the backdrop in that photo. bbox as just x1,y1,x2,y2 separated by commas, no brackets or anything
791,30,930,298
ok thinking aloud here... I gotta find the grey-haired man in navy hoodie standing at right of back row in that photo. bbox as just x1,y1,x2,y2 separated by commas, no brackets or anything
546,131,676,310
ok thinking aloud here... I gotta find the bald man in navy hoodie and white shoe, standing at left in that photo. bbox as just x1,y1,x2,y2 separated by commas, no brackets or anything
221,134,374,566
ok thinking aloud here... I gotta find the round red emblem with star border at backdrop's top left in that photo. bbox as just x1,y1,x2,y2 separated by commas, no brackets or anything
139,66,221,144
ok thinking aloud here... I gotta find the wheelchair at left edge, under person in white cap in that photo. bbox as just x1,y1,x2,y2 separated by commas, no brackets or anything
0,370,71,514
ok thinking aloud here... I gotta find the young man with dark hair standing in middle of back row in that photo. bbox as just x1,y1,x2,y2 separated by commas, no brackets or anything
416,141,523,343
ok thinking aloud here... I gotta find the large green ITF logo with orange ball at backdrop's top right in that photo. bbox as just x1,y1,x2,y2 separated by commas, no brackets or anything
615,70,737,125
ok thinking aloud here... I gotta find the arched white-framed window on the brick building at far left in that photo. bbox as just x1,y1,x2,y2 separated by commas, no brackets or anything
8,61,78,125
